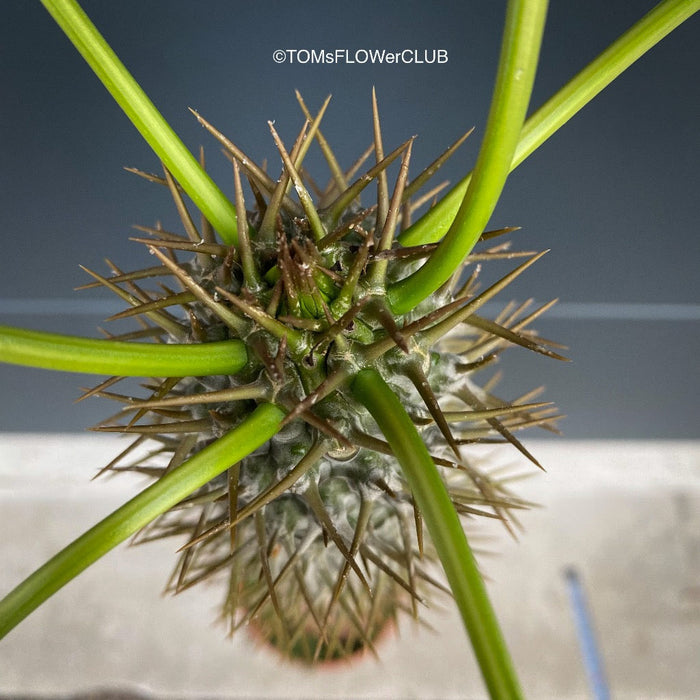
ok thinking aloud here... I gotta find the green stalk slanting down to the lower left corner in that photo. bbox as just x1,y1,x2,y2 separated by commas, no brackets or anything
0,404,284,638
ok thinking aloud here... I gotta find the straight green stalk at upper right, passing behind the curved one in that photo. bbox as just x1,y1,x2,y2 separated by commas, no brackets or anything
398,0,700,246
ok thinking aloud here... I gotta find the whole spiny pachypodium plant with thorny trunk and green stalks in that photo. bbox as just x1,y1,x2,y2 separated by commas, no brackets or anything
0,0,700,697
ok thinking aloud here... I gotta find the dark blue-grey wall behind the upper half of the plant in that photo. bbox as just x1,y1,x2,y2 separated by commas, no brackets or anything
0,0,700,438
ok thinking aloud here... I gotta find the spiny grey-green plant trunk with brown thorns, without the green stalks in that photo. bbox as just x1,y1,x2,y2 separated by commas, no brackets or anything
74,93,560,659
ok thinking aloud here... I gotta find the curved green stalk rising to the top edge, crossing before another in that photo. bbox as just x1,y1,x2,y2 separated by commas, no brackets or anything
387,0,547,314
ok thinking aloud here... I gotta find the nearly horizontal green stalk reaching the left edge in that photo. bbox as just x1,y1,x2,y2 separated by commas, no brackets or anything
0,326,248,377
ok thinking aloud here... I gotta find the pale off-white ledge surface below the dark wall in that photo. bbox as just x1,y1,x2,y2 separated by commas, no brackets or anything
0,434,700,699
